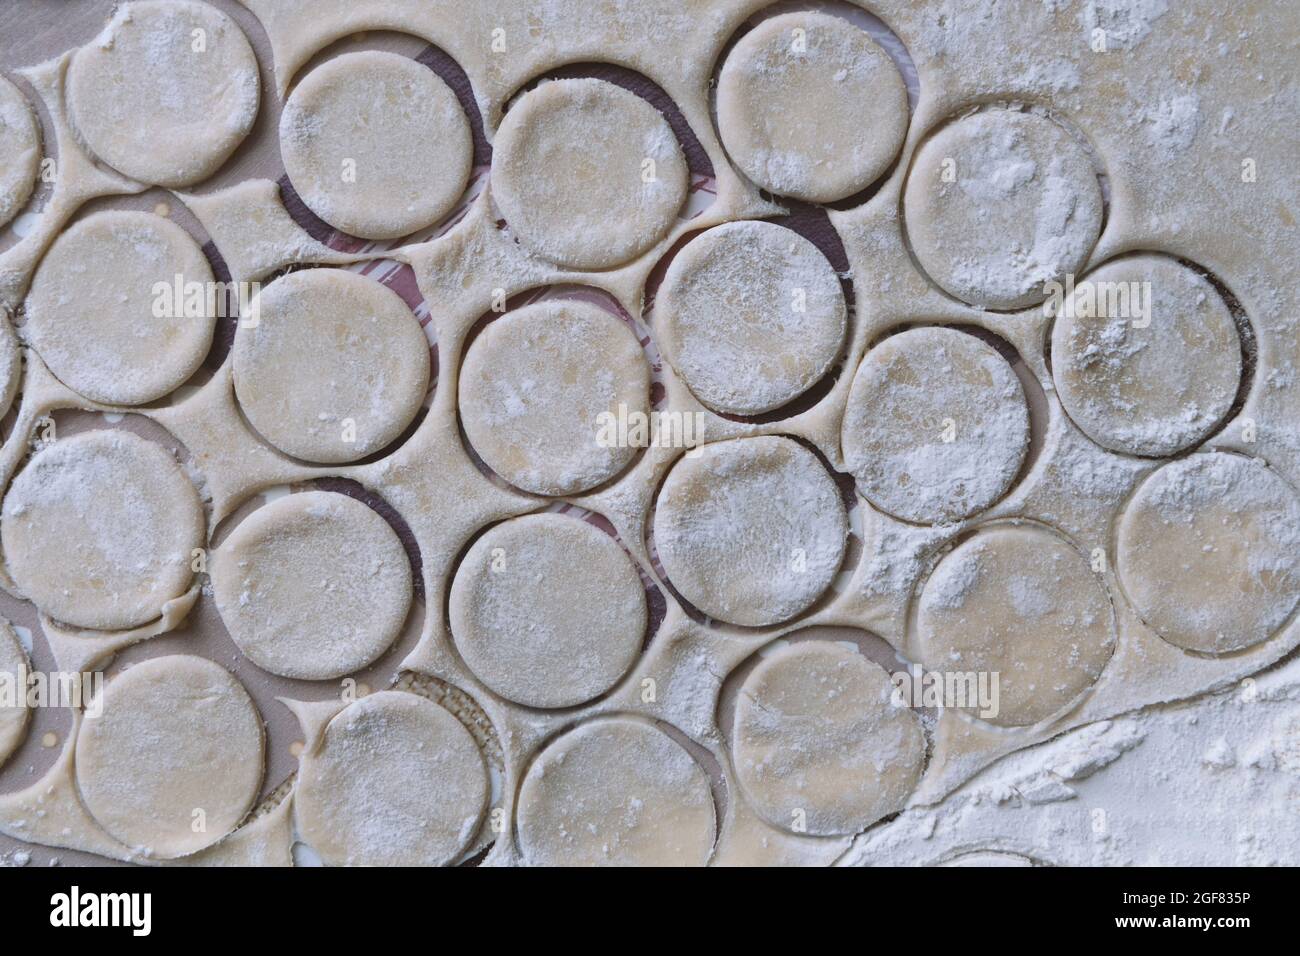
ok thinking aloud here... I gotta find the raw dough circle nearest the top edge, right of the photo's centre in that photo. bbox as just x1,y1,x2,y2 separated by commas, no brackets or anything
718,13,909,203
